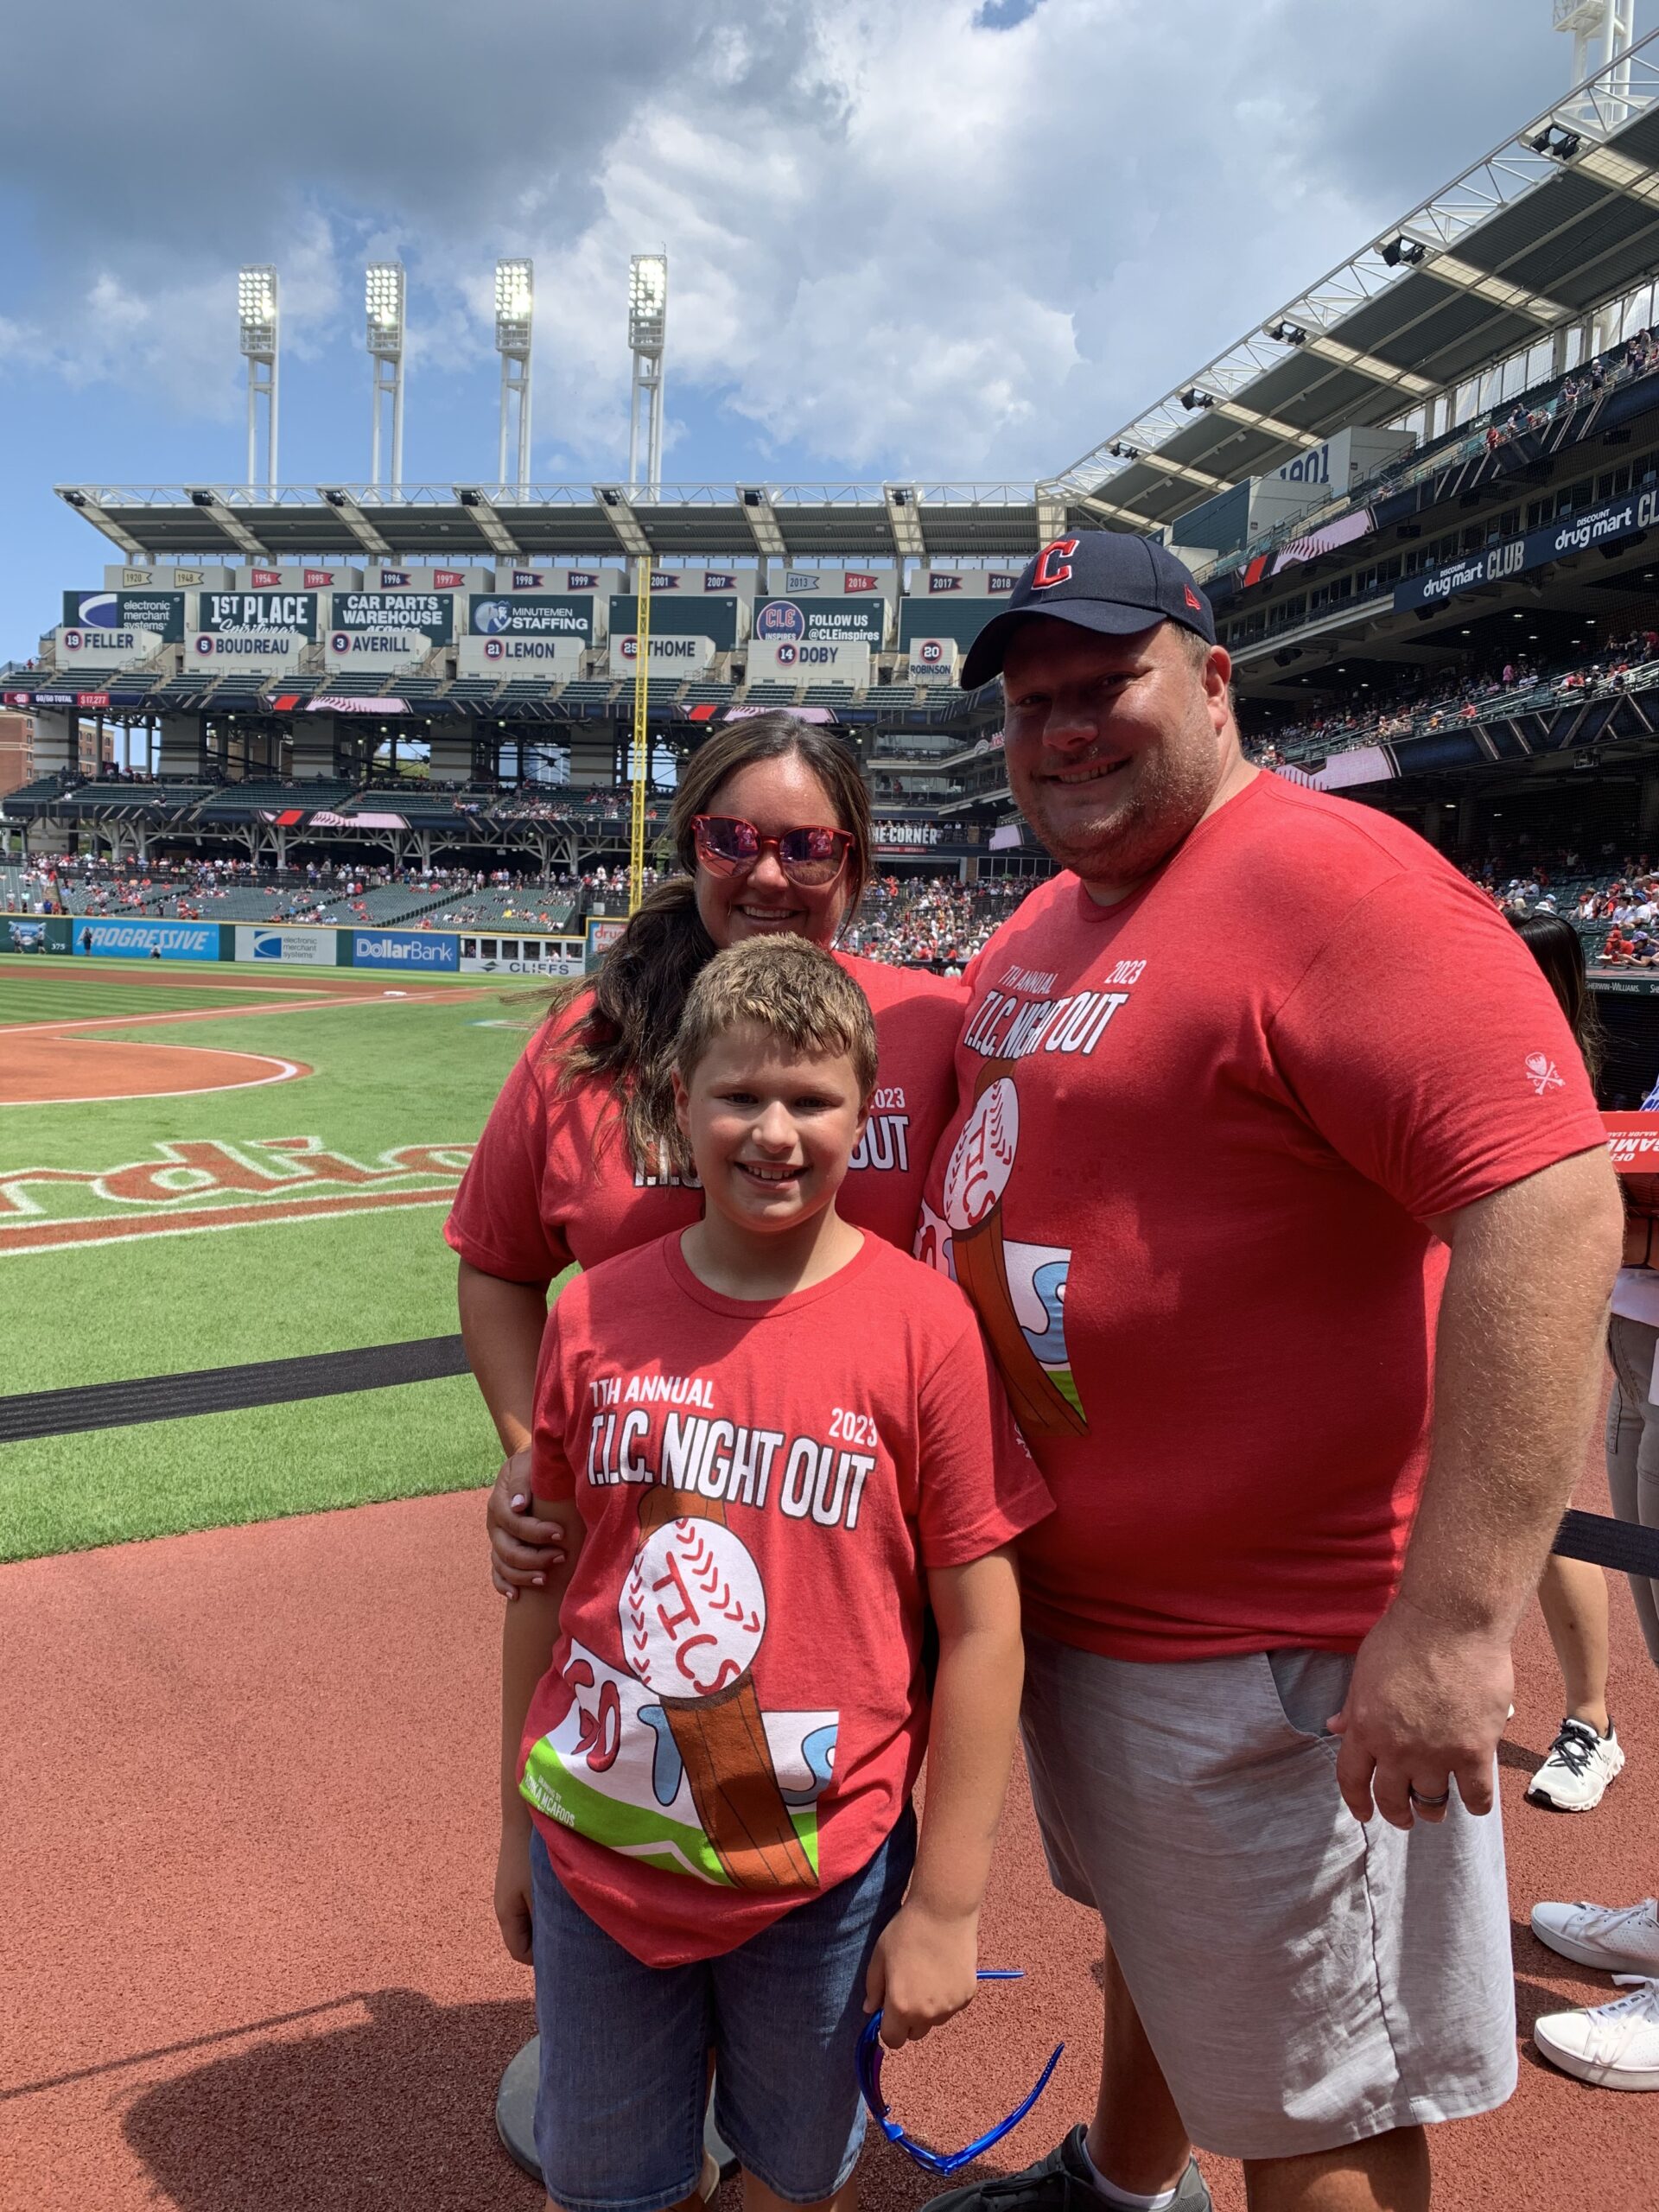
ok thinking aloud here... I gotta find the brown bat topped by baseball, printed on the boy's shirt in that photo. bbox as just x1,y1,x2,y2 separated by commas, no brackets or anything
617,1491,818,1889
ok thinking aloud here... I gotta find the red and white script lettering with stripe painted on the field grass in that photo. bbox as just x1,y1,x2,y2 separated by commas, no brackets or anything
0,1137,471,1256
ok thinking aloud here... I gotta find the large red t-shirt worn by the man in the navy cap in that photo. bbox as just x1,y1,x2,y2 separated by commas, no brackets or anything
918,774,1604,1659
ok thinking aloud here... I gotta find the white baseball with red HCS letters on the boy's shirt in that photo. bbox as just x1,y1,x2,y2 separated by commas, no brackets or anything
617,1517,766,1699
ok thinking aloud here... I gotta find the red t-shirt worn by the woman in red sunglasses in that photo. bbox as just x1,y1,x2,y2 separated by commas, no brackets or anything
445,953,967,1285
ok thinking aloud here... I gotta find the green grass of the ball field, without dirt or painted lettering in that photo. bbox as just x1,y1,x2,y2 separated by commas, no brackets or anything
0,963,566,1560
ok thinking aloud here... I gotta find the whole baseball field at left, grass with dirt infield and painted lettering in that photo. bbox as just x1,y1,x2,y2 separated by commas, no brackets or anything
0,956,553,1560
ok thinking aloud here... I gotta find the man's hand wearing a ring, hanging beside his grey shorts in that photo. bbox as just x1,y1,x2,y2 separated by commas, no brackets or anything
1327,1599,1516,1827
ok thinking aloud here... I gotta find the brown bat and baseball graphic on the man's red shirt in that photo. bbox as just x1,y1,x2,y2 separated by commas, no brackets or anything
944,1059,1089,1435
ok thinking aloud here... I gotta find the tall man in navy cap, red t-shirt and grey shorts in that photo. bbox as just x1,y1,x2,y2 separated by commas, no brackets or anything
918,533,1619,2212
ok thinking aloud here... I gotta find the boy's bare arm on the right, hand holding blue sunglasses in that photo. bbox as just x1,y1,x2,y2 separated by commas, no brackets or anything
865,1548,1024,2050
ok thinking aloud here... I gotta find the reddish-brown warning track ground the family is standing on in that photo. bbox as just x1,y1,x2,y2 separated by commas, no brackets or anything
0,1453,1659,2212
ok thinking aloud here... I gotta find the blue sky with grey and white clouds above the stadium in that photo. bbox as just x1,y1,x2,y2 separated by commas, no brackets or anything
0,0,1659,655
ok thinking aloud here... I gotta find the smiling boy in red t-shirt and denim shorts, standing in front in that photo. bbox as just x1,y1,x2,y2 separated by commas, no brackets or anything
495,936,1051,2212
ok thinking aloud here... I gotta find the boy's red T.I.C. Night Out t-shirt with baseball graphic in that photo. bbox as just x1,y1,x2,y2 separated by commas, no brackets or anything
520,1232,1048,1967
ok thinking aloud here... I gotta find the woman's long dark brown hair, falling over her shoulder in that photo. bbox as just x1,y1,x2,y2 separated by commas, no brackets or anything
550,712,869,1164
